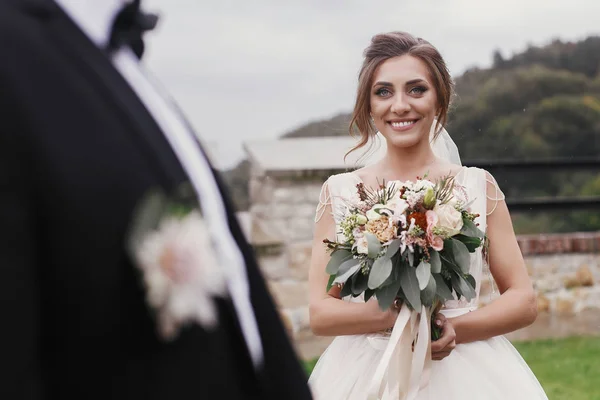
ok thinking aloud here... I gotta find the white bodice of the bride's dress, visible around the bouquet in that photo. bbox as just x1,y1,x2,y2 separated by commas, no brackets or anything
315,167,504,309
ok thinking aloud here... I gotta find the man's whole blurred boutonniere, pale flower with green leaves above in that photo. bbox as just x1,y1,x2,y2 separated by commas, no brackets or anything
127,184,226,340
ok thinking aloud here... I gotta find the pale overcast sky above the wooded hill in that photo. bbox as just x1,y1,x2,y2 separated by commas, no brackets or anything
143,0,600,167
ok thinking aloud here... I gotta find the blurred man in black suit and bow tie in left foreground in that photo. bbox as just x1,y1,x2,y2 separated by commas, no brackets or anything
0,0,310,400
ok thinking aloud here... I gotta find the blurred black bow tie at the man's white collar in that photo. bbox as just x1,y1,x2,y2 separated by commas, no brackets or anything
108,0,158,58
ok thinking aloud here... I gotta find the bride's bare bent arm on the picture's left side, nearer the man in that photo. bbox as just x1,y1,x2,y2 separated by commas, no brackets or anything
308,183,397,336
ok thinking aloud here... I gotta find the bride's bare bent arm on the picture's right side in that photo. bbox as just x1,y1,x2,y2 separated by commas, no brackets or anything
450,175,537,343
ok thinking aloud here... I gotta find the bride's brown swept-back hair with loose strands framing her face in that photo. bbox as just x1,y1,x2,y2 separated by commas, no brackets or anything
346,32,454,155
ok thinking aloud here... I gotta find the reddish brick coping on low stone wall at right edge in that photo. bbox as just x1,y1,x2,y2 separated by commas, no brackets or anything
517,232,600,256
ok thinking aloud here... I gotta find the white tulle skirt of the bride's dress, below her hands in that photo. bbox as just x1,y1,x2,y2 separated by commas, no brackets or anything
309,318,547,400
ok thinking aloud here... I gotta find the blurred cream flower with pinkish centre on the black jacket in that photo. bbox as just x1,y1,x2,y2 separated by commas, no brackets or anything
136,212,226,339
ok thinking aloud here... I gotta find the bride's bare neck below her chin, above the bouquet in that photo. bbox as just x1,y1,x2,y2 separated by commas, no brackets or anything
381,140,437,179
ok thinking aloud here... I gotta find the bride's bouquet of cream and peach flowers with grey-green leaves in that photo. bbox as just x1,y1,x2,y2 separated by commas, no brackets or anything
323,176,484,340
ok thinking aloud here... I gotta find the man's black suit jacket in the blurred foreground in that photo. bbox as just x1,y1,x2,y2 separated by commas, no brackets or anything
0,0,310,400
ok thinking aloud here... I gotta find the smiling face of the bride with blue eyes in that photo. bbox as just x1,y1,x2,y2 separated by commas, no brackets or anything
371,55,437,147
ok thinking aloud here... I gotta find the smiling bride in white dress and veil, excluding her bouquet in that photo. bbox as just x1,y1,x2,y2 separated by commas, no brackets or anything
309,32,547,400
